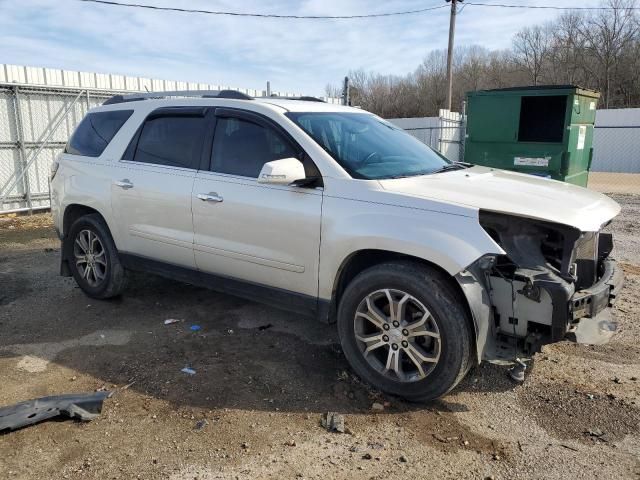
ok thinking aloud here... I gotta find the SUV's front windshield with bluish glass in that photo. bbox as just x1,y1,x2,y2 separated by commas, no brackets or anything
287,112,451,180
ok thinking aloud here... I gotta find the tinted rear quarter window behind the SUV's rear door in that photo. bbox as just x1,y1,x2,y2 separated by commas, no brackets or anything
64,110,133,157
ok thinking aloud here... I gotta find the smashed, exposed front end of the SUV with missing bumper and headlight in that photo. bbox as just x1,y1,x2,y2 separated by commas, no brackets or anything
457,211,623,361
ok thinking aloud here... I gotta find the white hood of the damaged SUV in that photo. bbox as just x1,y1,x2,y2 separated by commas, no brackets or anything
380,166,620,232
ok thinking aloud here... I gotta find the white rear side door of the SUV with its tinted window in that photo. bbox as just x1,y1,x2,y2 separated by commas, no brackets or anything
112,107,209,269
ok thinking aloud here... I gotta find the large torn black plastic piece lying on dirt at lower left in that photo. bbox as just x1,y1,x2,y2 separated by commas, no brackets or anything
0,391,111,433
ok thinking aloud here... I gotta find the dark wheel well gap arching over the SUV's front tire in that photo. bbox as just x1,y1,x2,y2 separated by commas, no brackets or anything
330,250,475,356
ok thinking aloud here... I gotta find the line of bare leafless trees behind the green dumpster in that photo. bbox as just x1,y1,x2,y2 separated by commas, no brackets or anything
326,0,640,118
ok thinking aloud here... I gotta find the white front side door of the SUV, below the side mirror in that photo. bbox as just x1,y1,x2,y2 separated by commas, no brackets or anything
193,108,322,302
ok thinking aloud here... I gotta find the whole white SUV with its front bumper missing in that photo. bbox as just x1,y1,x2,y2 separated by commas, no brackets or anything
51,91,622,400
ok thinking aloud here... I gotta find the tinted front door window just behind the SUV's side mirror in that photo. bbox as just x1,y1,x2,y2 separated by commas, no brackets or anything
211,117,297,178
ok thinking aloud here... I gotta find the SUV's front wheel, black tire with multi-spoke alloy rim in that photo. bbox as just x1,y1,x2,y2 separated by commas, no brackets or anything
338,262,473,401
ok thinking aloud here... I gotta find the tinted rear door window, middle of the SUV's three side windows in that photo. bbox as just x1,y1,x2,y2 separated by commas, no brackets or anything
131,115,206,169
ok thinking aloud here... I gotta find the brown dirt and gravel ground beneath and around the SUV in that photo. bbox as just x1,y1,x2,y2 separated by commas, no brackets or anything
0,196,640,480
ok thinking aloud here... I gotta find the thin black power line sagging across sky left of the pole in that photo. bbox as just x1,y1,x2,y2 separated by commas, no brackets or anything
78,0,448,20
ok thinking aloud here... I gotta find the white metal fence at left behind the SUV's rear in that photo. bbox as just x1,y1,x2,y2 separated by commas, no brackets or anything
0,64,339,213
